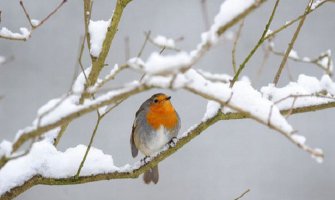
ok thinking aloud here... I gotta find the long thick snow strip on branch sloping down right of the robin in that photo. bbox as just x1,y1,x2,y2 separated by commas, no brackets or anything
181,69,293,134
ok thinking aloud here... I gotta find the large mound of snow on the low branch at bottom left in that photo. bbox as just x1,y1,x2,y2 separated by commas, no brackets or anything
0,141,119,195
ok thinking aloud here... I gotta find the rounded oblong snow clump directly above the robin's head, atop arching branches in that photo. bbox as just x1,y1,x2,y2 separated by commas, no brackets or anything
144,52,192,75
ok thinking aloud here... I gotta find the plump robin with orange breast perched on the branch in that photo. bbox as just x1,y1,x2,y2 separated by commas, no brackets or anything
130,93,180,184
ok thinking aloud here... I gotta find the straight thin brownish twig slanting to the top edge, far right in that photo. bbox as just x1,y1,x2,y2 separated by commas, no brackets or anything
273,0,313,86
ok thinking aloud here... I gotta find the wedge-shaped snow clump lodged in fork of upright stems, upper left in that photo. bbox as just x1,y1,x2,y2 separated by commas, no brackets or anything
88,20,111,57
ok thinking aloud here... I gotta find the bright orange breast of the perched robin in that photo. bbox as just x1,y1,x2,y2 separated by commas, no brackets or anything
146,102,178,129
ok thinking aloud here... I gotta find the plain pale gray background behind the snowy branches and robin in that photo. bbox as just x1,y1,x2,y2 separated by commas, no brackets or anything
0,0,335,200
